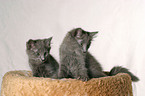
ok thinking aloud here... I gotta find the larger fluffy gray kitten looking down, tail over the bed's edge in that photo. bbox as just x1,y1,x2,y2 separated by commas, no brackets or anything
58,28,139,81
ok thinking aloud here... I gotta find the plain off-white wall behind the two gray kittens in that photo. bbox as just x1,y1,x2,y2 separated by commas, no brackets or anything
0,0,145,96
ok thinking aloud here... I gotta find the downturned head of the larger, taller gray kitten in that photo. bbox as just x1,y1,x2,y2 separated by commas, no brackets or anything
71,28,98,53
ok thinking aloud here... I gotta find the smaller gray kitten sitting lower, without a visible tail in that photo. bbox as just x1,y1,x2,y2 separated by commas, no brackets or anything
26,37,59,78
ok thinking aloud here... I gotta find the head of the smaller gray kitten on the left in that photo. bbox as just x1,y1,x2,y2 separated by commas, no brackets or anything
26,37,52,63
